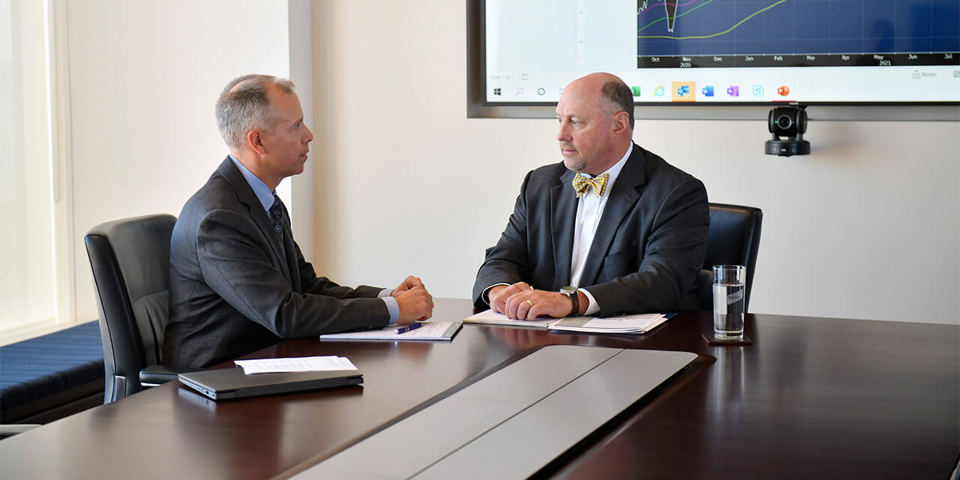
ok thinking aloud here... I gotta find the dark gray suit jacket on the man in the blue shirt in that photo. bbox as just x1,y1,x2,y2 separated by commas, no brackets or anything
163,157,390,368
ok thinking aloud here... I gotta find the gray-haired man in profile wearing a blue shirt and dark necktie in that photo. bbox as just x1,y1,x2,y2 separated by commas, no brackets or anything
163,75,433,369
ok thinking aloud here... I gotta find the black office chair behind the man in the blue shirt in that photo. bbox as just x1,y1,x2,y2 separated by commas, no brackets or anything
84,215,177,403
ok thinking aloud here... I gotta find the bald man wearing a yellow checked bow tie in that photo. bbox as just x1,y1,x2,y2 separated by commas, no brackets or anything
473,73,710,320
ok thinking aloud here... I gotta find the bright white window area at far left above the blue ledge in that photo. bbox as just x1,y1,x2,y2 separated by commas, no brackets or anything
0,0,55,330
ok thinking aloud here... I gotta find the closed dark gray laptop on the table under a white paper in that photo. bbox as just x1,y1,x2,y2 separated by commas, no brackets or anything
177,367,363,400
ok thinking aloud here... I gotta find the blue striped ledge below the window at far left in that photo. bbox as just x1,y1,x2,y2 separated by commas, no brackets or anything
0,322,103,409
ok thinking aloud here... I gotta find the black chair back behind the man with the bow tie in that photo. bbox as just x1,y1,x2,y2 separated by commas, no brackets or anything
697,203,763,312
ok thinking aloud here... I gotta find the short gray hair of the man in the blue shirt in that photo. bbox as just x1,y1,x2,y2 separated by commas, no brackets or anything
216,74,293,150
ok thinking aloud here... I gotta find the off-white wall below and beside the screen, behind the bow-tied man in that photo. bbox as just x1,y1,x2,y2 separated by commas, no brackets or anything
311,0,960,323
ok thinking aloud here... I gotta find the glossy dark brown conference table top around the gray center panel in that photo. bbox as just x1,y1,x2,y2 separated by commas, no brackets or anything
0,299,960,479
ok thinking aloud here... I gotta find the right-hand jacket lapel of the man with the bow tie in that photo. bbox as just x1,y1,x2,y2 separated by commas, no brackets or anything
567,144,647,285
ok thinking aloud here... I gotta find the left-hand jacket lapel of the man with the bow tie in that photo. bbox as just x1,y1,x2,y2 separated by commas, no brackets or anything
539,170,577,290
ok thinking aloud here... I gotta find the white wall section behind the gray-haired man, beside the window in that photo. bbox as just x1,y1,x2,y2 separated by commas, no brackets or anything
67,0,298,320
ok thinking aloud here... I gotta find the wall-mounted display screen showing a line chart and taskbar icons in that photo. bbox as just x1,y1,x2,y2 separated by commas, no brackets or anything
481,0,960,105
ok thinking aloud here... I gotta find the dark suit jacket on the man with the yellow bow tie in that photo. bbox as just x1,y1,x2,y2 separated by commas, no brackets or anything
473,144,710,316
